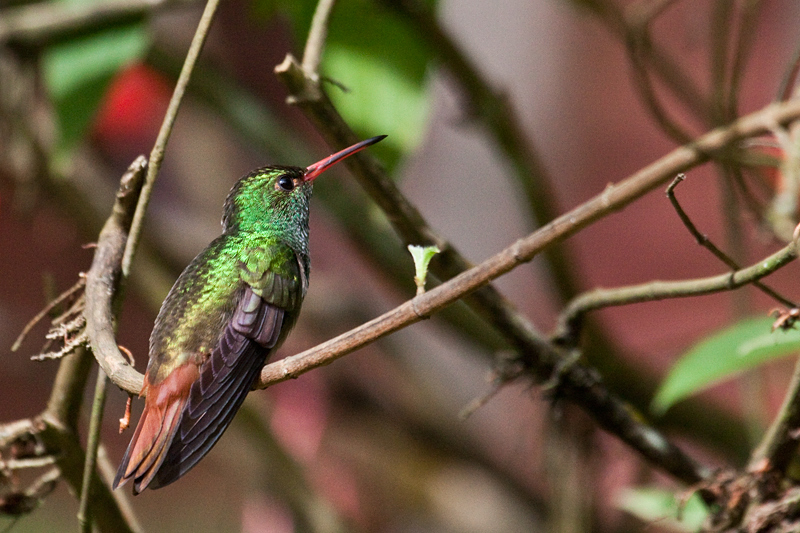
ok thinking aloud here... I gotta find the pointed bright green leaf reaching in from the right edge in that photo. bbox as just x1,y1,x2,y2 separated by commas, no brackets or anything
651,317,800,414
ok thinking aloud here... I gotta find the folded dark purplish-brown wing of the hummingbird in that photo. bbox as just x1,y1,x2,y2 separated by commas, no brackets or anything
145,285,285,488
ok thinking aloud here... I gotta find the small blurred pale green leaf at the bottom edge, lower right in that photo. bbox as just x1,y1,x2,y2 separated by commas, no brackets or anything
616,487,708,532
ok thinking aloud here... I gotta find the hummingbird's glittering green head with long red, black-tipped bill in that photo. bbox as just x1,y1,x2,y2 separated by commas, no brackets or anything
222,135,386,251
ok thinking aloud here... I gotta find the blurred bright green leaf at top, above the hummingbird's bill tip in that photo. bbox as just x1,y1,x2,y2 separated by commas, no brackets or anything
254,0,435,167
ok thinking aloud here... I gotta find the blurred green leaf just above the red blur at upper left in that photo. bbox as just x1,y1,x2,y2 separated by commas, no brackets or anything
42,23,150,149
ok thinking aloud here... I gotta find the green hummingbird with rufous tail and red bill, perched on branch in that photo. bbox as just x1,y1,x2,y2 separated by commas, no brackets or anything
113,135,386,494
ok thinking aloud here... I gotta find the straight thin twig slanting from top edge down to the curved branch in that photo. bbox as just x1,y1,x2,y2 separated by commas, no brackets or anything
122,0,219,278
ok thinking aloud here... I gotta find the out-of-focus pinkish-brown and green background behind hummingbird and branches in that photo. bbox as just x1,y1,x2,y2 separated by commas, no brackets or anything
0,0,800,533
